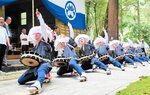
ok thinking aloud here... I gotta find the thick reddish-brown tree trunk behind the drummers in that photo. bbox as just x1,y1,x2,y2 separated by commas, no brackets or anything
108,0,118,40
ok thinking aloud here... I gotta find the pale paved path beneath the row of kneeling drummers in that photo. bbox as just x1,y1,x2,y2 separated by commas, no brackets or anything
0,64,150,95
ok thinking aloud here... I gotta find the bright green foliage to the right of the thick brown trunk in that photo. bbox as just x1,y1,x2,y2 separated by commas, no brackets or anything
119,0,150,44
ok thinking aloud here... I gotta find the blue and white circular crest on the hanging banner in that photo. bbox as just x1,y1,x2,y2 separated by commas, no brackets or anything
65,1,76,20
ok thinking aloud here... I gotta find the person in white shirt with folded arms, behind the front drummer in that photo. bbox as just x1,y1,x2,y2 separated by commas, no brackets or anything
20,28,29,53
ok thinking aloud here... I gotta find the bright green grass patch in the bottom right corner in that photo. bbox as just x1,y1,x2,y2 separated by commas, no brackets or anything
116,76,150,95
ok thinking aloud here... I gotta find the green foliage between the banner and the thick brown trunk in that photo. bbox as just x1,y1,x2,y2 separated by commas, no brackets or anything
86,0,108,37
